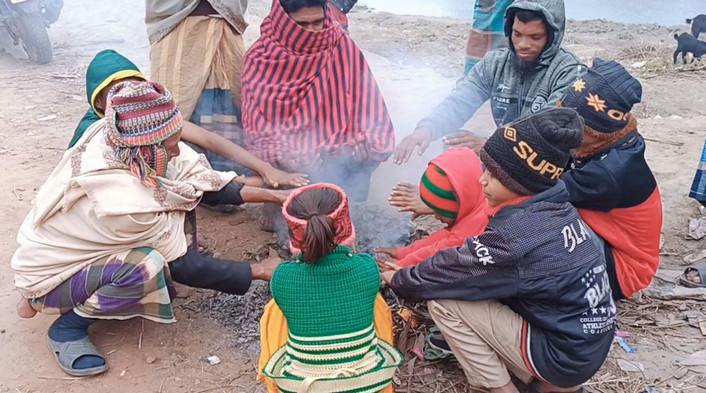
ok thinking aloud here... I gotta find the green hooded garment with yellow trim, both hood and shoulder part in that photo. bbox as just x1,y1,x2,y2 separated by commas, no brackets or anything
69,49,147,149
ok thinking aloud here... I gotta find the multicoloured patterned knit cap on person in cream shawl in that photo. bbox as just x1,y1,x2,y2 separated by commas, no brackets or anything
105,81,183,187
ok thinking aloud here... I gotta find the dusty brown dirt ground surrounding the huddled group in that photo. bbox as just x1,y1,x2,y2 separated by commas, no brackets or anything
0,0,706,393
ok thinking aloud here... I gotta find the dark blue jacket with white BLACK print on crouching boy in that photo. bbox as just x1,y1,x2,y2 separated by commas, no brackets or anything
392,181,616,387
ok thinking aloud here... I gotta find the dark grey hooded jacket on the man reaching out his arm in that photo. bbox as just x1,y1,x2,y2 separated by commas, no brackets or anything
418,0,586,139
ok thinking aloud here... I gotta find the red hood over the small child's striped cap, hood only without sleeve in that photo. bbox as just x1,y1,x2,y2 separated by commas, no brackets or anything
430,147,486,225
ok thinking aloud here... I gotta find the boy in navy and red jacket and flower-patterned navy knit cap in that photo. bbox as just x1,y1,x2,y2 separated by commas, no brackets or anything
560,59,662,300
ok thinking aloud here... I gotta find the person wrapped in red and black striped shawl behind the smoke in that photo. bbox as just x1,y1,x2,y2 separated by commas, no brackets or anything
242,0,395,201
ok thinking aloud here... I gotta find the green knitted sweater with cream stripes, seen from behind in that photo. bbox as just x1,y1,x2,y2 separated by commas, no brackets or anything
263,246,404,393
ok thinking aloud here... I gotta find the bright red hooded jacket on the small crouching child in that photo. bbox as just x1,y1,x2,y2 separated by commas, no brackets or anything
397,147,488,267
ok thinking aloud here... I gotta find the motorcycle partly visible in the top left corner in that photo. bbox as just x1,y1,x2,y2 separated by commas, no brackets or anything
0,0,64,64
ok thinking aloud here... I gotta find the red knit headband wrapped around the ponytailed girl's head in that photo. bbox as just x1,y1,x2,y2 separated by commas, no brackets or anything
282,183,355,255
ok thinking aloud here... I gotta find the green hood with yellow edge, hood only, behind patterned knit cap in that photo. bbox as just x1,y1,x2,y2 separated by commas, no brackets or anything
86,49,147,117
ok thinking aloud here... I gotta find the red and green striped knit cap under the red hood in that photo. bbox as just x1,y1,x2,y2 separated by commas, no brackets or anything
419,163,462,219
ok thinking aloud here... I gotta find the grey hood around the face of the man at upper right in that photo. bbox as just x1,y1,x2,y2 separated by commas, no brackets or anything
505,0,566,66
